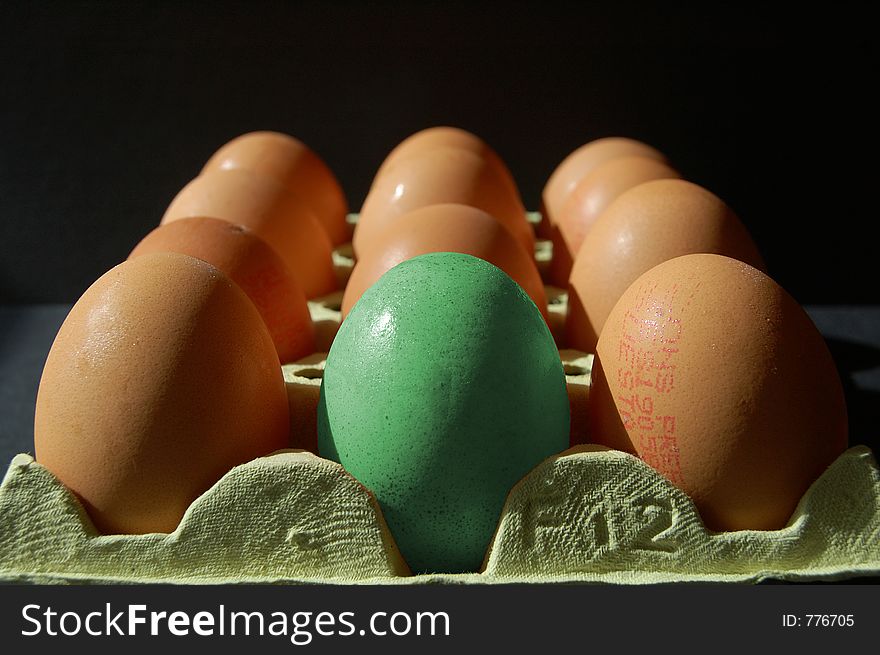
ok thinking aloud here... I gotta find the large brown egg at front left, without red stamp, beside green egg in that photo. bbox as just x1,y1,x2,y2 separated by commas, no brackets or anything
34,253,289,533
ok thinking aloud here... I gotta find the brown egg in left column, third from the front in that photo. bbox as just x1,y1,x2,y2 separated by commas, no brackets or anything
162,169,336,298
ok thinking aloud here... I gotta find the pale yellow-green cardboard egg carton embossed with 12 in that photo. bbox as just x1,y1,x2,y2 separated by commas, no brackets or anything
0,213,880,584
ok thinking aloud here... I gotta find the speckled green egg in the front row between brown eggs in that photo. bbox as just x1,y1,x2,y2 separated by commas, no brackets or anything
318,253,569,573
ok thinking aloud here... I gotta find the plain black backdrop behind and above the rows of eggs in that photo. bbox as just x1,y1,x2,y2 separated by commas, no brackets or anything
0,1,877,304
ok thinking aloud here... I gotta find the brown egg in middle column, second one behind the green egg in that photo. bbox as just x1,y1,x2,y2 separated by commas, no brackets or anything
353,146,535,257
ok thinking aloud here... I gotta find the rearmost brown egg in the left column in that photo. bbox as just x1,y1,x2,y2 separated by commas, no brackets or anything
202,132,351,246
